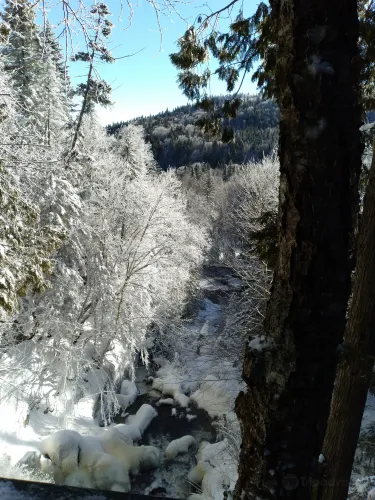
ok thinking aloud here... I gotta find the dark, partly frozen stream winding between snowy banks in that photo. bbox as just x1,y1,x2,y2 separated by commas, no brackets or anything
108,268,241,498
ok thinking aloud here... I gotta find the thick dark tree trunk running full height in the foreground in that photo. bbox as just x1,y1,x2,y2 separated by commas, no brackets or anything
236,0,362,500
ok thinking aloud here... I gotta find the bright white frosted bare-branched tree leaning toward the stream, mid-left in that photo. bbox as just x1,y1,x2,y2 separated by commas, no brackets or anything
80,117,205,380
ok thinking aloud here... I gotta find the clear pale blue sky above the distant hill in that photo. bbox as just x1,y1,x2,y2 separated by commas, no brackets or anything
63,0,259,125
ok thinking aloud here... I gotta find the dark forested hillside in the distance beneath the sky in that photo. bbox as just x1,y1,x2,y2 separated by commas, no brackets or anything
107,95,279,170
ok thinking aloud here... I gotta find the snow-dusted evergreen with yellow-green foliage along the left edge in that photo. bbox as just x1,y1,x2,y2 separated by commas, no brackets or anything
0,61,65,316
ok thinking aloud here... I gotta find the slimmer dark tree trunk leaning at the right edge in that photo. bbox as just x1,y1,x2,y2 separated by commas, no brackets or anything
317,142,375,500
